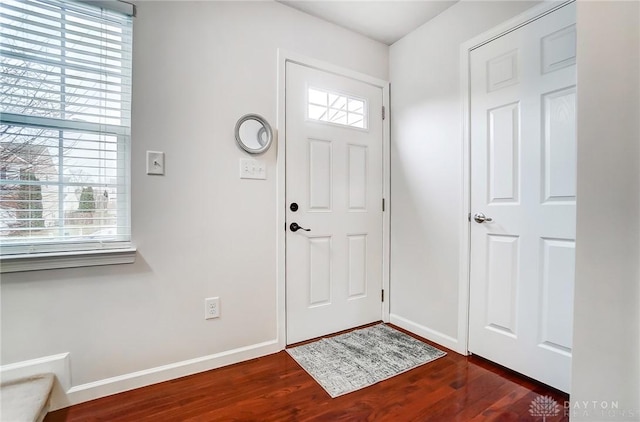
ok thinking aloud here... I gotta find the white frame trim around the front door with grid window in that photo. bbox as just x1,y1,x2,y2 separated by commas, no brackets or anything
276,49,391,349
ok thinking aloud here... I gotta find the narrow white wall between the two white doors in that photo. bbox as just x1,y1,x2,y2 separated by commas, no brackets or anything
389,1,535,352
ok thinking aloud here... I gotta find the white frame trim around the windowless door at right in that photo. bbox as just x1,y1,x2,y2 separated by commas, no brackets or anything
456,0,576,355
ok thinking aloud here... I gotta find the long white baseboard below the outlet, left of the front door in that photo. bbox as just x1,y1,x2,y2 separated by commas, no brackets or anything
66,340,283,406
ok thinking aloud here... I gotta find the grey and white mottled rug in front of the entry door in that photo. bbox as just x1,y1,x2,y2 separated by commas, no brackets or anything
287,324,446,398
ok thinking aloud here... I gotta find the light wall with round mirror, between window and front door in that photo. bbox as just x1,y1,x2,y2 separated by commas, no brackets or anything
1,2,388,401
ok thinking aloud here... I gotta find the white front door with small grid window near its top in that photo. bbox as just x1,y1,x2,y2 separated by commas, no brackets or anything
286,62,383,344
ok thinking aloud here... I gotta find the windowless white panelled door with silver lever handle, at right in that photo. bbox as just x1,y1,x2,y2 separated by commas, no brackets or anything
469,4,576,392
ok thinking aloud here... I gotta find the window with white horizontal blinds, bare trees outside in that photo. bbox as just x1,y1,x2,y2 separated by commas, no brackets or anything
0,0,132,256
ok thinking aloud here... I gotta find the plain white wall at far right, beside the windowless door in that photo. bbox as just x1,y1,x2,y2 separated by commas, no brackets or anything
571,2,640,421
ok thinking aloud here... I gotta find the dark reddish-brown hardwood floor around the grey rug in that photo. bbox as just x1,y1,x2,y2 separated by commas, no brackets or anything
45,327,569,422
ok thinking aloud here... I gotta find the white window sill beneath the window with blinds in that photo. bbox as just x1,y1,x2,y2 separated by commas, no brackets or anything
0,247,136,273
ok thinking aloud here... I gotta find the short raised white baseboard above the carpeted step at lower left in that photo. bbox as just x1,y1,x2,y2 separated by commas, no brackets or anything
0,353,71,410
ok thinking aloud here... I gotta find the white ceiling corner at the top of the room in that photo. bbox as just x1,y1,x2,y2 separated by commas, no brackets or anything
277,0,458,45
